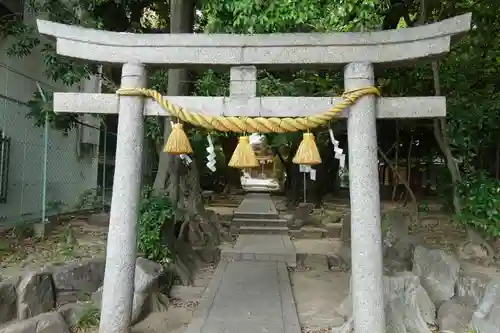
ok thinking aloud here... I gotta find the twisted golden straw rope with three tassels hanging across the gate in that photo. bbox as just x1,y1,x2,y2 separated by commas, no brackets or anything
116,87,380,168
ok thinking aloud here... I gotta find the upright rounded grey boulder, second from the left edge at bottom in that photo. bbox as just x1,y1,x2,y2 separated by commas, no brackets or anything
17,271,56,320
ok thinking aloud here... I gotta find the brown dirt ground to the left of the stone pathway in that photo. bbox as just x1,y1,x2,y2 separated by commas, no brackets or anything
0,211,219,333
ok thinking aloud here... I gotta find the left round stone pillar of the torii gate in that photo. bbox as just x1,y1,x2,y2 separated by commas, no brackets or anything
99,63,146,333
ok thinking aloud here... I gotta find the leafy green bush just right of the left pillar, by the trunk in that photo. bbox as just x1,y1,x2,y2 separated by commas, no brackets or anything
138,187,175,264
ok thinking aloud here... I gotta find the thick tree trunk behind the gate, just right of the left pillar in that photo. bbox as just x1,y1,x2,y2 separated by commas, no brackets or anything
153,0,220,244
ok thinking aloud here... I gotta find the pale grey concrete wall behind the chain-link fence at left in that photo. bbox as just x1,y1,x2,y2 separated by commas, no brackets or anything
0,1,98,226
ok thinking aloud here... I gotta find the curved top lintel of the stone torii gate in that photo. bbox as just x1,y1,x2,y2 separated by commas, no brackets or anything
37,13,472,67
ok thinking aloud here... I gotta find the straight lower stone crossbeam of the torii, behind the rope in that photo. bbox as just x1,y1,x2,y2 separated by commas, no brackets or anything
54,92,446,119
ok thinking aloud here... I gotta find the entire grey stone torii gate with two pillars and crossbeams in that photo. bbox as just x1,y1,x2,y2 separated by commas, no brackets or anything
37,14,471,333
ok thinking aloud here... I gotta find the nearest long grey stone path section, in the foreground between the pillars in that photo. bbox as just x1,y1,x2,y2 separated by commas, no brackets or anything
185,260,300,333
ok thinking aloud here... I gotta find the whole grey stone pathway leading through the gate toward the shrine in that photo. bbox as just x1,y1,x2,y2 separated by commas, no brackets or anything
186,194,301,333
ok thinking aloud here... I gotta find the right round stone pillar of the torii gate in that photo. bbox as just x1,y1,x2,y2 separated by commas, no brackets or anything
344,62,385,333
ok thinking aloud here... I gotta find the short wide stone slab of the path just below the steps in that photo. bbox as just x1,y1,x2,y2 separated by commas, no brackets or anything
221,235,297,267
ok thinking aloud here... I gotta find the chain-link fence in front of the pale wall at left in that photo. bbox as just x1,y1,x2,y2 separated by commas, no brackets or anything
0,62,114,229
